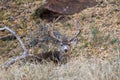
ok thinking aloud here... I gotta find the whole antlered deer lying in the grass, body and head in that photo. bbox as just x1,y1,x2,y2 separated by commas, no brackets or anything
28,21,80,64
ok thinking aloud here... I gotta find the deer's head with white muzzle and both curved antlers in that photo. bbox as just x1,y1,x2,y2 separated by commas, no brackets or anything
49,20,80,55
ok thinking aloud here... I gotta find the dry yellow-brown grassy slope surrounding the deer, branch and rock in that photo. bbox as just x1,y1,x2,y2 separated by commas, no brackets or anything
0,0,120,80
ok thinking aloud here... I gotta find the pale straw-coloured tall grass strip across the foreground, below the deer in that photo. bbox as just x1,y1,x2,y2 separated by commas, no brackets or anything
0,52,120,80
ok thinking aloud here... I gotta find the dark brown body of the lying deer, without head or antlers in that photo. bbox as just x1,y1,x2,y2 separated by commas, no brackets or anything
29,51,68,64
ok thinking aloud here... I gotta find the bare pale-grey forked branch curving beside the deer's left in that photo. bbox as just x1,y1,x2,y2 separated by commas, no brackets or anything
0,26,33,68
